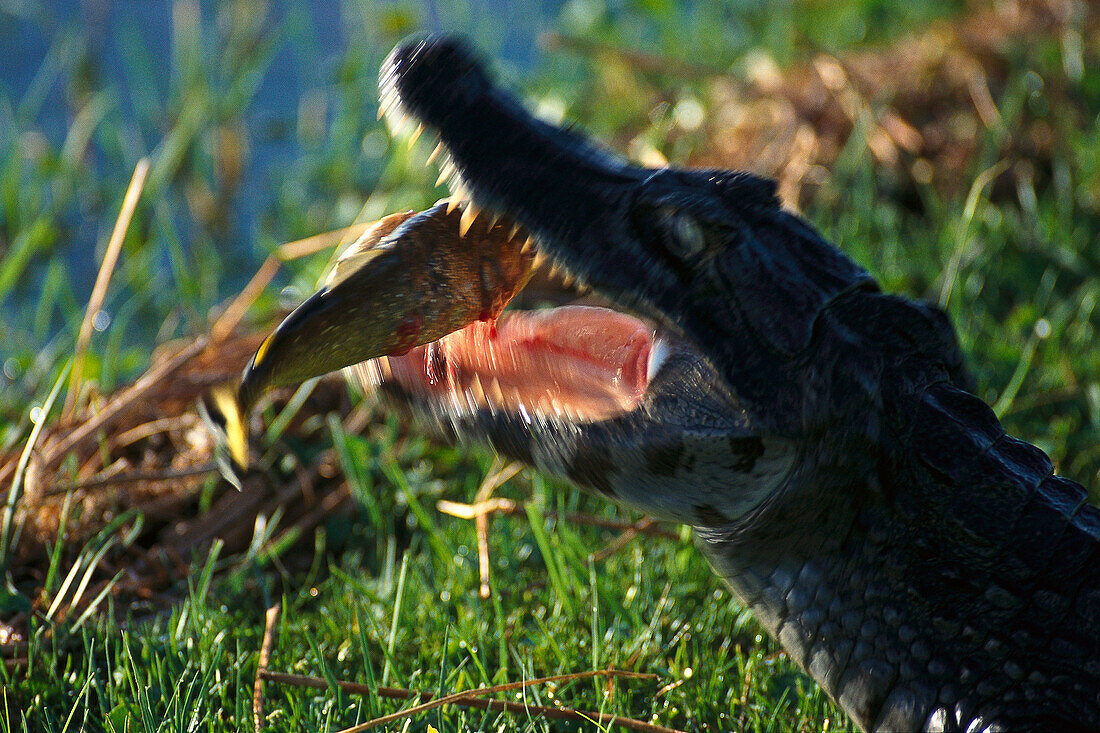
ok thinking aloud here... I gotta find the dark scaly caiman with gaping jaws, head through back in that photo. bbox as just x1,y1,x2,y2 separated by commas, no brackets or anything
229,36,1100,731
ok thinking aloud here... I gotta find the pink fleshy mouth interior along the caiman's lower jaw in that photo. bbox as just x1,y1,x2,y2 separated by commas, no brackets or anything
388,306,653,420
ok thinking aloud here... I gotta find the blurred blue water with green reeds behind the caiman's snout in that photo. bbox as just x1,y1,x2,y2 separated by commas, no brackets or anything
0,0,976,387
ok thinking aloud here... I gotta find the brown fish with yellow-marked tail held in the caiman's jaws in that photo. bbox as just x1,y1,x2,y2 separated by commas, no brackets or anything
213,199,537,467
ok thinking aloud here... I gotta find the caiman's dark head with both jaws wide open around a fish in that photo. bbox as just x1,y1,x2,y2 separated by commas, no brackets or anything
234,37,963,526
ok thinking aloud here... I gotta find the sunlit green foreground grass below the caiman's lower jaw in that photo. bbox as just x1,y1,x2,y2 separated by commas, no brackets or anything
8,457,837,731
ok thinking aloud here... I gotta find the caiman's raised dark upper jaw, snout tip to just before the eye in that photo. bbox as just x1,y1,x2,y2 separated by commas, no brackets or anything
380,36,674,327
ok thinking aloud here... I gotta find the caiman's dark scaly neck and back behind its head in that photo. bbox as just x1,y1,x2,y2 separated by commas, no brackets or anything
697,288,1100,731
